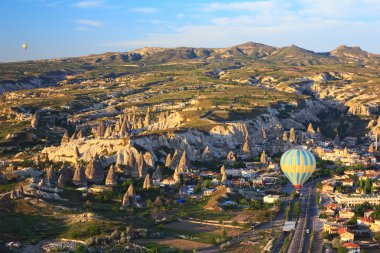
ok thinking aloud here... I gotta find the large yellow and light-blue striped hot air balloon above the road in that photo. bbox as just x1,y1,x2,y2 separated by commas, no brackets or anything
280,149,316,190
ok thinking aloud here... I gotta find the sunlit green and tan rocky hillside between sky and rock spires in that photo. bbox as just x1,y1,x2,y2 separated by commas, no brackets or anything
0,43,380,157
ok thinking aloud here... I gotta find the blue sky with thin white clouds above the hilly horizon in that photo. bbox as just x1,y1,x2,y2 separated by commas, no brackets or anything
0,0,380,62
